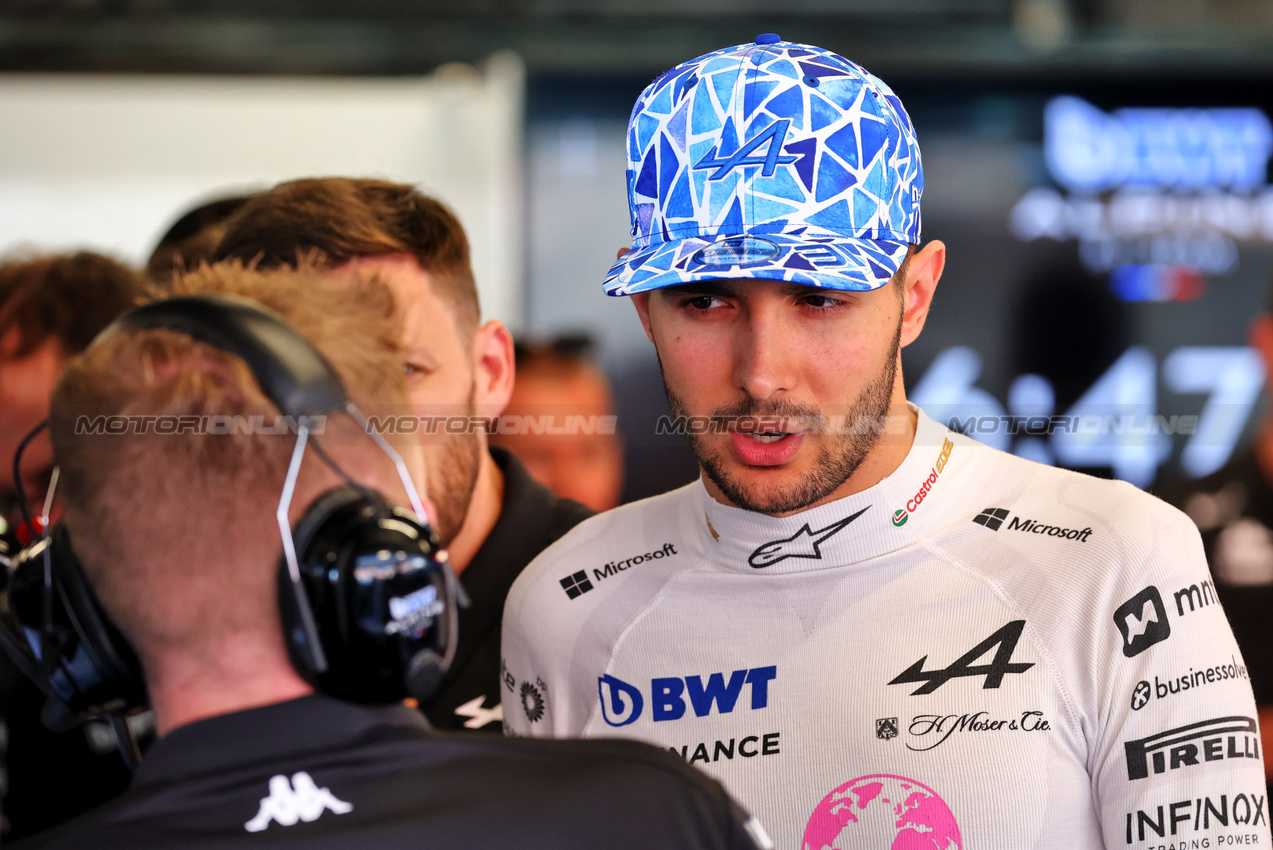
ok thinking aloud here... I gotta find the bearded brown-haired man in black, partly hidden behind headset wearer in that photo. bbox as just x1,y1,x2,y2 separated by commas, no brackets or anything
216,178,591,732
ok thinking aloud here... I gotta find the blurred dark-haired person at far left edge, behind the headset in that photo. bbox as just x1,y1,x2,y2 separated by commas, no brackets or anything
0,252,144,840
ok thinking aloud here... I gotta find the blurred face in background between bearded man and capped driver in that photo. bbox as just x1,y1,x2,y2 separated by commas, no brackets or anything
491,336,624,512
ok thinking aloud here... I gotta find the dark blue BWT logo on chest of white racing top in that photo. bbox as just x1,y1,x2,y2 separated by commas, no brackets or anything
597,665,778,727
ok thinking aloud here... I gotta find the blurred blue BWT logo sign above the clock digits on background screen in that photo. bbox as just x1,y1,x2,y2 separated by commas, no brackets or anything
1009,95,1273,295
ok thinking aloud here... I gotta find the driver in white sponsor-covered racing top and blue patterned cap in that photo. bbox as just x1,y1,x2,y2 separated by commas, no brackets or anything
503,36,1270,850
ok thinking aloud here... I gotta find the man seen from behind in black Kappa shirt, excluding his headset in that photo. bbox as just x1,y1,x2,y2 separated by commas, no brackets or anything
17,263,756,850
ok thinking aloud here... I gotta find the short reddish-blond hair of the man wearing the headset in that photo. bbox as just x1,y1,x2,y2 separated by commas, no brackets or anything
50,262,406,660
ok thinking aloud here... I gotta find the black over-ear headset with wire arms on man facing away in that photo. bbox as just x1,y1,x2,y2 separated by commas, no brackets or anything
0,295,462,752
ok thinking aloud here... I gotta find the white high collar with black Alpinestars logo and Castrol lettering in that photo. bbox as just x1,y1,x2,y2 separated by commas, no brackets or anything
695,406,967,574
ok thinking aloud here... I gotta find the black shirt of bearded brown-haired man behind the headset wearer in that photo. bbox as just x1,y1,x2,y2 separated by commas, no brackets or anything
420,447,593,734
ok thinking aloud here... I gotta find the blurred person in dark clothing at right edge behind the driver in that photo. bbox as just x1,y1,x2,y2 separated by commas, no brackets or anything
1161,277,1273,799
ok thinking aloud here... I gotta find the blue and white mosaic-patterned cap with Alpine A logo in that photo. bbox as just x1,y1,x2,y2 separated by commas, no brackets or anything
603,34,924,295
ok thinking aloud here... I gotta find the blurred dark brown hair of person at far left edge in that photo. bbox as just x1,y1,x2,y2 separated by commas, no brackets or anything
0,251,145,358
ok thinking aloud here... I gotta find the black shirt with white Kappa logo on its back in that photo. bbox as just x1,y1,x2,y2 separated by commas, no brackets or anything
15,696,768,850
